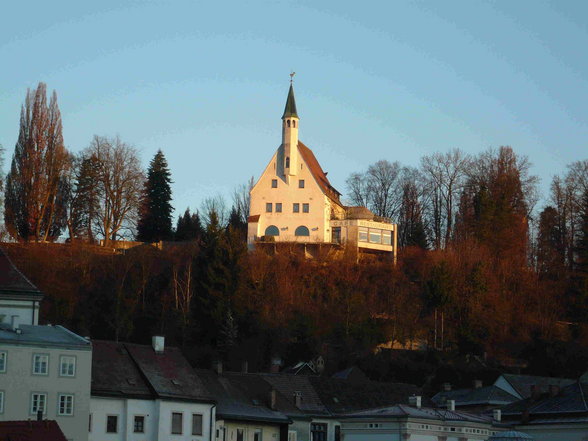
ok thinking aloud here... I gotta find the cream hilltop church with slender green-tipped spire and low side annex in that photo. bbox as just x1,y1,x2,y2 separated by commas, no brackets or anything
247,84,397,258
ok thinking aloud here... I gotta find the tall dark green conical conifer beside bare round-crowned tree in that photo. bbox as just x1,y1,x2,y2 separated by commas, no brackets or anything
137,150,173,242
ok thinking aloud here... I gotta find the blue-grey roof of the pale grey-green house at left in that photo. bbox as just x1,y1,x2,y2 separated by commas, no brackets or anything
0,323,91,351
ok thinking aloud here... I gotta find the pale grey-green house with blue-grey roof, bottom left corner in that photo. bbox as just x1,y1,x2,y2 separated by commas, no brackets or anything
0,323,92,441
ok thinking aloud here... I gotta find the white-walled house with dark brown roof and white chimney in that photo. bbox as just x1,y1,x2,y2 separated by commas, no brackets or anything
93,337,215,441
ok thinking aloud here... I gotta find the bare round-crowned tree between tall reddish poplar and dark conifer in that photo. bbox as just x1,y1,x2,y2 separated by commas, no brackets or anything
85,136,144,245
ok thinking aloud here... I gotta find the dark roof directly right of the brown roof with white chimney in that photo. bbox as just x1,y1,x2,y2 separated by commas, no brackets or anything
196,369,290,424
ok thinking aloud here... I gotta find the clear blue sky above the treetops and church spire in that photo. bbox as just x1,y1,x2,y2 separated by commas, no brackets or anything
0,0,588,219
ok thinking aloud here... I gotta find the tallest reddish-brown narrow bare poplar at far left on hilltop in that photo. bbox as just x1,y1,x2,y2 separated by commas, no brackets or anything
4,83,67,241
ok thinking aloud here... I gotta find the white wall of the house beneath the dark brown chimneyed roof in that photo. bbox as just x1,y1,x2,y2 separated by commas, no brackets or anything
89,396,215,441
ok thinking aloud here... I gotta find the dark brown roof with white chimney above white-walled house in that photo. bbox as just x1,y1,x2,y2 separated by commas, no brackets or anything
92,340,214,402
